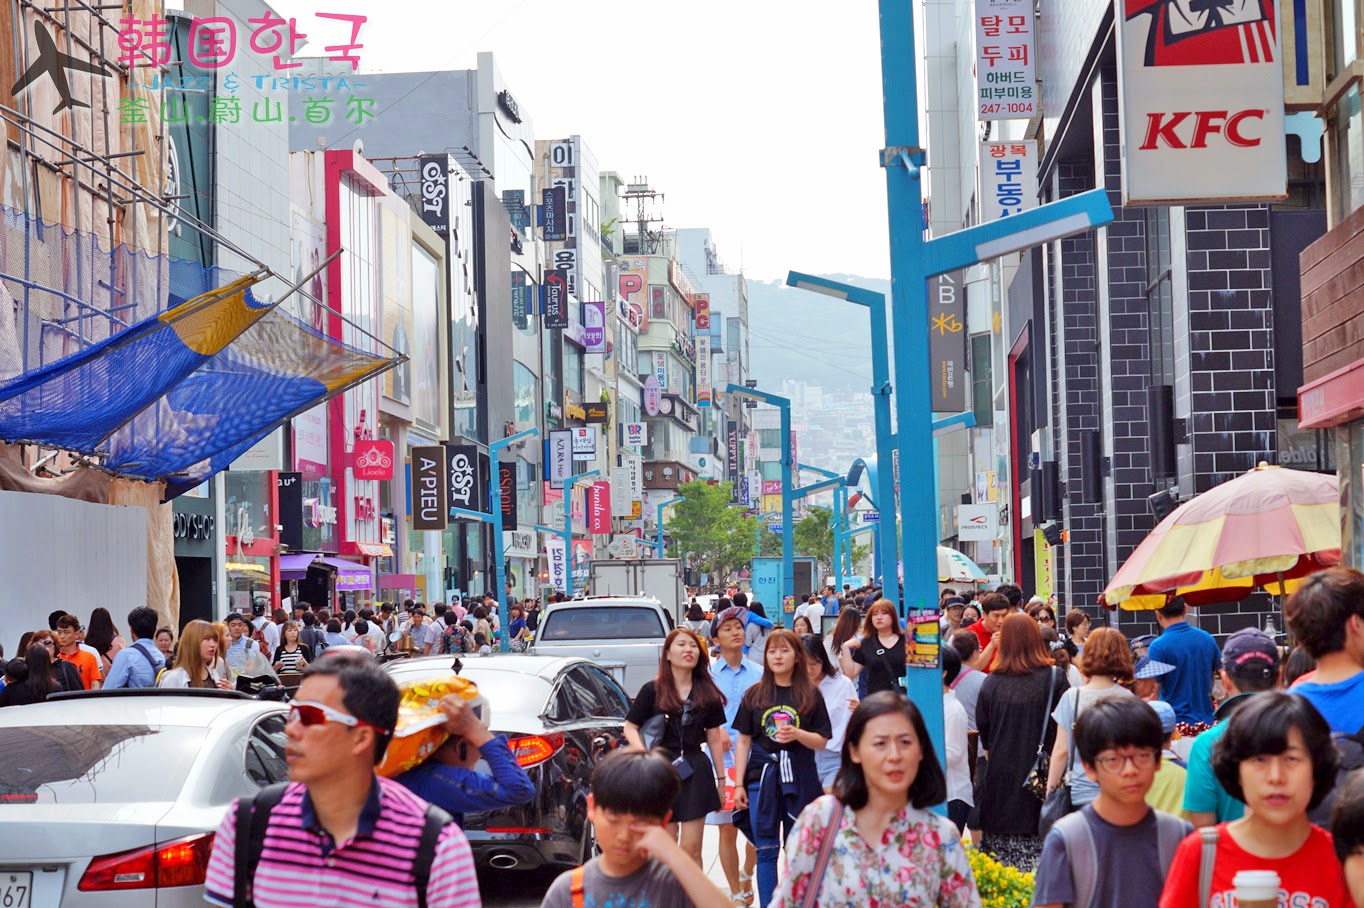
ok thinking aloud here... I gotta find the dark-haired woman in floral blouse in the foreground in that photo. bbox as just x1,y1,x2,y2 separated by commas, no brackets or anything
771,691,981,908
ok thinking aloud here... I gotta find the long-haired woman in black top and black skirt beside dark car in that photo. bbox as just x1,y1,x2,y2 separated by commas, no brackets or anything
625,627,730,867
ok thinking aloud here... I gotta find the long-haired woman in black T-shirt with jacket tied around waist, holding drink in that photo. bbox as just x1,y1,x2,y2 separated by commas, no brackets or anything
734,629,833,908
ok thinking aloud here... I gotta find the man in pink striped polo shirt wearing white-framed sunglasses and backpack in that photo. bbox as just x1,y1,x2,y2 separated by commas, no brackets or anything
205,653,481,908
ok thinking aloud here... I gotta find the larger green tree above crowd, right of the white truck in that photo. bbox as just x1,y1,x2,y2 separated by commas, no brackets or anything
666,480,757,578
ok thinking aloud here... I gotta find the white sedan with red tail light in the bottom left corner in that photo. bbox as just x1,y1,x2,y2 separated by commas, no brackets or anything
0,688,288,908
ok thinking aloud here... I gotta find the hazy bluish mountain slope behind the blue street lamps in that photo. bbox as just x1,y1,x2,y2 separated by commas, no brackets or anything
749,274,891,391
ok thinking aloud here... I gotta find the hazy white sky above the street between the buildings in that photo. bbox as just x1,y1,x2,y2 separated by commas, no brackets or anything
273,0,889,279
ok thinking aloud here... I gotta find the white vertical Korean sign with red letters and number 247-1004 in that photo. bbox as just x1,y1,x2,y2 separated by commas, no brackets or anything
975,0,1038,120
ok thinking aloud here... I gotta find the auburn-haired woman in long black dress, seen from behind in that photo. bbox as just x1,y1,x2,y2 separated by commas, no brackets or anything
975,612,1069,873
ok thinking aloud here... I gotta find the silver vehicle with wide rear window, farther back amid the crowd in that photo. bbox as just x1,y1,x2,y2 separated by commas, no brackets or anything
531,596,672,698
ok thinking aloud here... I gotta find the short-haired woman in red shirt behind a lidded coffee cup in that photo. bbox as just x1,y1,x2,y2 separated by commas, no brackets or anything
1161,691,1354,908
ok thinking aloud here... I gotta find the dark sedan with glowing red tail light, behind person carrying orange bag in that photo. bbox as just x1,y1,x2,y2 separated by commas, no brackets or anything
383,654,630,870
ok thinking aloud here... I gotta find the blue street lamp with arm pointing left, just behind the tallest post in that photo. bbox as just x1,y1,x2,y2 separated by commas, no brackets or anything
786,271,900,603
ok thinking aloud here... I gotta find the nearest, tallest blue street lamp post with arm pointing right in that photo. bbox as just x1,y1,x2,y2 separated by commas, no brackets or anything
878,0,1113,755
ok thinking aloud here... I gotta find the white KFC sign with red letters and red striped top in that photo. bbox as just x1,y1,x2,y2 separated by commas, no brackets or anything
1117,0,1288,206
